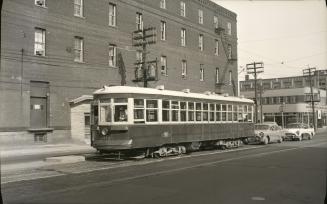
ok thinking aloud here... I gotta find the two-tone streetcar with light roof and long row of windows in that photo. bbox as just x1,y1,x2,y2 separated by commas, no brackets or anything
91,86,254,157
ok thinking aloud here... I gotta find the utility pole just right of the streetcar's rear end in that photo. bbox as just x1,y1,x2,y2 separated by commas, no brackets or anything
246,62,264,123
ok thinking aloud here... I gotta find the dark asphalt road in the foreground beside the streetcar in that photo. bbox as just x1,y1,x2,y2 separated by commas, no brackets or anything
2,132,327,204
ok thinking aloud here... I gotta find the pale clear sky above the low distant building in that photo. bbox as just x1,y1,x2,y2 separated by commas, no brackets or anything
212,0,327,80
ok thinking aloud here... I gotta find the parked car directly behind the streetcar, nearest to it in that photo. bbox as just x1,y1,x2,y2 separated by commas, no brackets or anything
254,122,283,145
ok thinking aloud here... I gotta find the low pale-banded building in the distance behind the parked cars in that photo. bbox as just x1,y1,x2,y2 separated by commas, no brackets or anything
240,70,327,127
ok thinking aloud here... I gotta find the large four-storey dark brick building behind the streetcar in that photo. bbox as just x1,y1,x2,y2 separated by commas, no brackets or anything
0,0,238,143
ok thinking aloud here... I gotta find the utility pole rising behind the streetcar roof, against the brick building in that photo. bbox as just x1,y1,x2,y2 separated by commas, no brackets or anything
132,27,157,87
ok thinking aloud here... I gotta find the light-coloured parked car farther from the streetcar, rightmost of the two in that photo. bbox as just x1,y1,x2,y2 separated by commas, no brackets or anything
283,123,315,141
